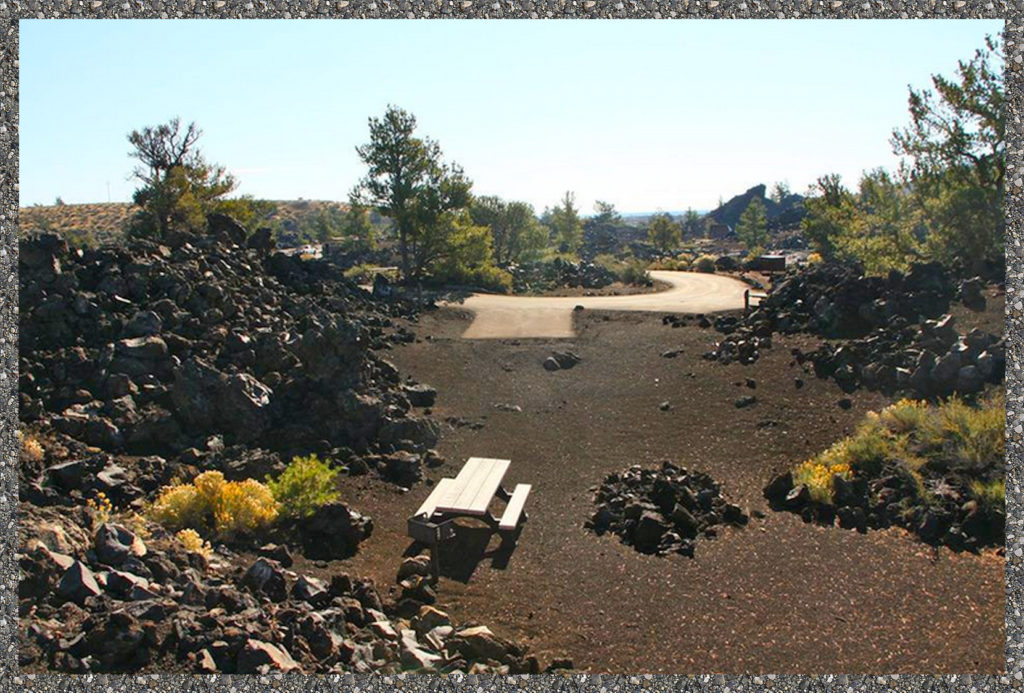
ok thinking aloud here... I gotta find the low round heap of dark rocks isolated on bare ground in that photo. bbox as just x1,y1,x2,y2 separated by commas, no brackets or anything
586,462,750,557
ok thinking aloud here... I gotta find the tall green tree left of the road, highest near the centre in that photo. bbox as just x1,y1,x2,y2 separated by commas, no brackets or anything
351,105,472,279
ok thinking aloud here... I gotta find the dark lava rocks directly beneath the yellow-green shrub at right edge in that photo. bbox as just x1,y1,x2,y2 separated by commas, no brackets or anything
764,461,1006,551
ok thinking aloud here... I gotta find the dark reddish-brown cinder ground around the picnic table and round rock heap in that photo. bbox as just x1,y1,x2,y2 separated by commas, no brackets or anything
331,310,1006,674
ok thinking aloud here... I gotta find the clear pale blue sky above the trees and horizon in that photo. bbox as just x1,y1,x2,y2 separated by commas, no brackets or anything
19,19,1002,213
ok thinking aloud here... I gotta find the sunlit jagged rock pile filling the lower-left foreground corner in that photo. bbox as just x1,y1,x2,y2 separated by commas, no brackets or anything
16,504,539,674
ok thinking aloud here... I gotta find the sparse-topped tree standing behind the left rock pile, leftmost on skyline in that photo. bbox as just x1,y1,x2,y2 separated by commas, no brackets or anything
128,118,238,234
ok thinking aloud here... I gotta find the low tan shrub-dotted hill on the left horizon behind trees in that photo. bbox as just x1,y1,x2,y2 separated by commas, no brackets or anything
18,200,348,245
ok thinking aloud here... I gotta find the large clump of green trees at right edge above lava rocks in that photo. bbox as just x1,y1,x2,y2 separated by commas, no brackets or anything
803,39,1006,274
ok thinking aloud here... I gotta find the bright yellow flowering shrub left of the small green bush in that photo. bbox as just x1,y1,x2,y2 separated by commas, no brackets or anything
147,472,279,539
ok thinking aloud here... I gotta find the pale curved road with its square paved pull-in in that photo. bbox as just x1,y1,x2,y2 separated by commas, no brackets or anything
461,271,750,339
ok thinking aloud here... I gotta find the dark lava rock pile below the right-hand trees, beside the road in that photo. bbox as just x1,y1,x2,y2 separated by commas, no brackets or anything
700,263,1006,397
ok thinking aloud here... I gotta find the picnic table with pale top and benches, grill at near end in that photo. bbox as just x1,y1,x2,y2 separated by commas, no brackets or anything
409,458,530,578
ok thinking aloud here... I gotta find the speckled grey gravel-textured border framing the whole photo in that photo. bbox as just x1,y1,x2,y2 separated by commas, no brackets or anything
0,0,1024,693
